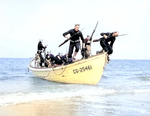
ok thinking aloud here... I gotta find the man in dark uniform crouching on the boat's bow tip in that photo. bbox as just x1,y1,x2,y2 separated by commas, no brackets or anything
100,32,119,55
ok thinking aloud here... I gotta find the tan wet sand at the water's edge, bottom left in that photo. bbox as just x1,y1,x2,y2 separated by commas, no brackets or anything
0,98,79,116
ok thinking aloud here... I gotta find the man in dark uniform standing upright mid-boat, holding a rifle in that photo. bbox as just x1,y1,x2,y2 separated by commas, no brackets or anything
63,24,85,61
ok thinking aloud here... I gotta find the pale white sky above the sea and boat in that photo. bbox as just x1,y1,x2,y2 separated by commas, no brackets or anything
0,0,150,60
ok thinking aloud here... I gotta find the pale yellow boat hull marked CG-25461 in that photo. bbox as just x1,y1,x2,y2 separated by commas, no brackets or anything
29,53,107,85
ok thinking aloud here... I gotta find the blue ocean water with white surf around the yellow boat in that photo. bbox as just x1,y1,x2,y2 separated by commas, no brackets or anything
0,58,150,116
